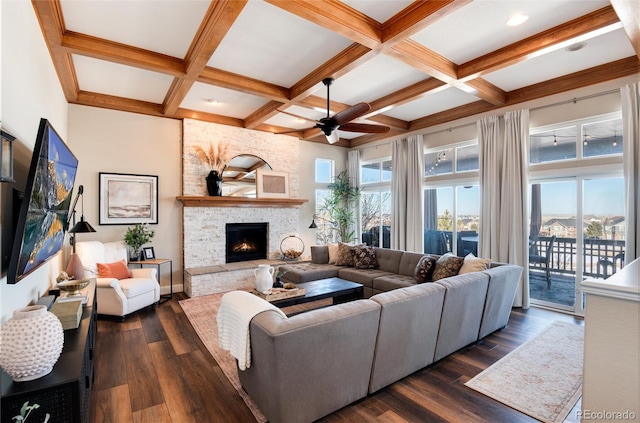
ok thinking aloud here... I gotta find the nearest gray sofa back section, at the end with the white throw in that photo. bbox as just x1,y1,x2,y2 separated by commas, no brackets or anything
238,299,380,423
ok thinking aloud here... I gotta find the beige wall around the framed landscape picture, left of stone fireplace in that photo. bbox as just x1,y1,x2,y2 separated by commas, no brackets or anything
65,104,182,293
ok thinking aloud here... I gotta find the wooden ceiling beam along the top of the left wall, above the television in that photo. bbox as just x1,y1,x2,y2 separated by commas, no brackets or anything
31,0,80,102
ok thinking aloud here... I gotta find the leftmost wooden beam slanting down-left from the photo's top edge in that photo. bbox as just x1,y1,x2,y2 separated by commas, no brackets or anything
163,0,248,116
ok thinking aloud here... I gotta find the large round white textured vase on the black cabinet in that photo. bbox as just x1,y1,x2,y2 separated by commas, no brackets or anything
0,305,64,382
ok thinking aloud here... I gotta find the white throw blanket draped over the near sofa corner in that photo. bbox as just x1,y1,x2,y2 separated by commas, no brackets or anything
216,291,287,370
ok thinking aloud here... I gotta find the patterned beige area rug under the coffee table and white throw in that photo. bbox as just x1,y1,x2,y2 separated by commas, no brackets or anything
180,294,331,423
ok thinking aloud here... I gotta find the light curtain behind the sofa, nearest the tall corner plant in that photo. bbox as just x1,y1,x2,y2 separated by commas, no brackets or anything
391,135,424,252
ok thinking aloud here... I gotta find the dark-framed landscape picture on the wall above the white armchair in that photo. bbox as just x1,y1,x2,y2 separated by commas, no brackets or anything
99,172,158,225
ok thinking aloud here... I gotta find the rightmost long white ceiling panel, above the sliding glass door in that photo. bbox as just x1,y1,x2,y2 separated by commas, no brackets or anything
484,29,634,91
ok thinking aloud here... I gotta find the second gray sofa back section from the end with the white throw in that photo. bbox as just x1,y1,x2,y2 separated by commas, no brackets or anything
369,283,445,393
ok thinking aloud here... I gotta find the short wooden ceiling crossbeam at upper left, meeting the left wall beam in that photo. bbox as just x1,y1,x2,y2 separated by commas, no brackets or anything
62,31,185,77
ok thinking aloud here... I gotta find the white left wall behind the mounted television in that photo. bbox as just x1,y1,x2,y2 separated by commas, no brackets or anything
0,1,67,322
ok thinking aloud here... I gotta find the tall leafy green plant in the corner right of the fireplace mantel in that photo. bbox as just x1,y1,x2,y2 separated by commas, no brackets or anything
321,170,360,242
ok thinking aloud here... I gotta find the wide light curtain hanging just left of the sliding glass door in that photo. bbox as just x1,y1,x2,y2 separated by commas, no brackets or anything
477,110,529,307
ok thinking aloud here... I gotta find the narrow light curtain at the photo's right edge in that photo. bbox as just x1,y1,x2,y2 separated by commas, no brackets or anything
620,83,640,264
